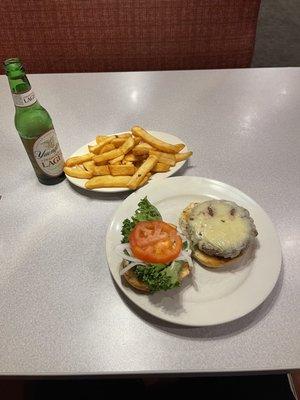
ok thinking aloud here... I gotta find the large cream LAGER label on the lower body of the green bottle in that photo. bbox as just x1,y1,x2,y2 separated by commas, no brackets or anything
33,129,64,176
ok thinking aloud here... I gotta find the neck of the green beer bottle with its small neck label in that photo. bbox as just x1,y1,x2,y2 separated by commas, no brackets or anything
4,59,37,108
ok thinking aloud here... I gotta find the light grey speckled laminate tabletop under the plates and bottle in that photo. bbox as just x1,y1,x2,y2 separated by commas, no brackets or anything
0,68,300,375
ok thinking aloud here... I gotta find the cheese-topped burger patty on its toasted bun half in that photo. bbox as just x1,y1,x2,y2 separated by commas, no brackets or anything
179,200,258,268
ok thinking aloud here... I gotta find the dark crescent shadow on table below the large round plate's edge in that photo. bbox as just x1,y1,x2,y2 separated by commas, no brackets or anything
114,265,284,340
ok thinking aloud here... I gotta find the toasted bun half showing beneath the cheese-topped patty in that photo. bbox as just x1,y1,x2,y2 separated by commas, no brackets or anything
181,202,243,268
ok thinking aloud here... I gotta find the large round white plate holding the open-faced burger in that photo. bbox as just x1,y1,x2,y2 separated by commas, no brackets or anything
106,176,281,326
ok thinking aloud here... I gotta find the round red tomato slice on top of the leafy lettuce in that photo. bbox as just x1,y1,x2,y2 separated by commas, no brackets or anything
129,221,182,264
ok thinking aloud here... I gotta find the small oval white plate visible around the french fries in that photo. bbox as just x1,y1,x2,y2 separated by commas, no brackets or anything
66,131,188,193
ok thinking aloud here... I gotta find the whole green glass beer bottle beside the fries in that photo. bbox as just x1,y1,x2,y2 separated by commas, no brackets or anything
4,58,65,185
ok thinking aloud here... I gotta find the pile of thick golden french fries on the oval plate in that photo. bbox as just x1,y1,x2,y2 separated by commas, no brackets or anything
64,126,193,190
